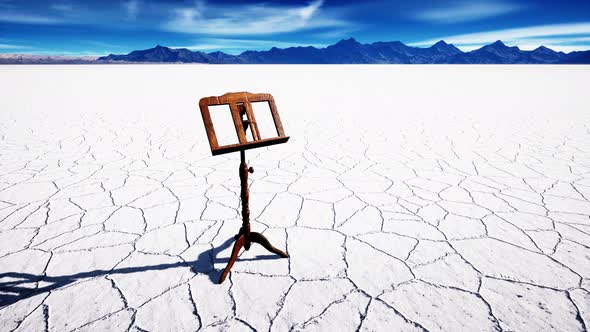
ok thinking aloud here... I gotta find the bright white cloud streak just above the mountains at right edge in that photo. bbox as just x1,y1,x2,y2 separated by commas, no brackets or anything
410,22,590,52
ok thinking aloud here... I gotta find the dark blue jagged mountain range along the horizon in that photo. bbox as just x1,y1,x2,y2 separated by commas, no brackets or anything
0,38,590,64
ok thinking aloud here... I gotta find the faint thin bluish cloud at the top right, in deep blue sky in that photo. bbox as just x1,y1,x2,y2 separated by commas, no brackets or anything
411,1,523,24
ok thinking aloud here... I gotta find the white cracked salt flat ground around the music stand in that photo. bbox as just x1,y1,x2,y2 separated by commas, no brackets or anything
0,65,590,331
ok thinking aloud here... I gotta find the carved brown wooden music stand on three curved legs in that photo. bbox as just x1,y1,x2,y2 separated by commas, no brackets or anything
199,92,289,284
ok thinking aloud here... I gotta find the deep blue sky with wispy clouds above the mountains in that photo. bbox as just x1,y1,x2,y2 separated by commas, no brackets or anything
0,0,590,55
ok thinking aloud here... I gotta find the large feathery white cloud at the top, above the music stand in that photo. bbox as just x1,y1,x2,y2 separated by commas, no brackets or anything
163,0,349,35
